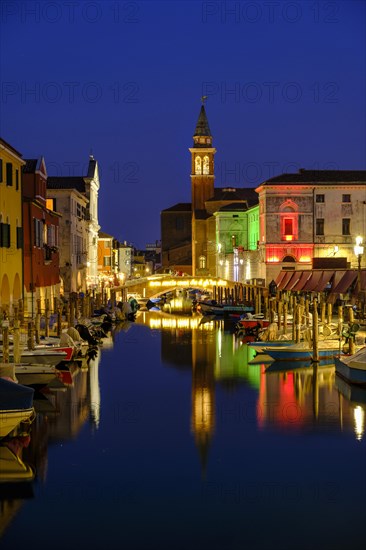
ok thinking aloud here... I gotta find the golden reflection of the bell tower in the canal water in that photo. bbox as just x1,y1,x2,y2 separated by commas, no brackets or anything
191,331,215,476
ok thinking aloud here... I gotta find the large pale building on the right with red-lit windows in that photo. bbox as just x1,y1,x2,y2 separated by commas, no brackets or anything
256,169,366,282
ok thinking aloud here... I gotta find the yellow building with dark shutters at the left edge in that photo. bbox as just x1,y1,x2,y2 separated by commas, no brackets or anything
0,138,25,313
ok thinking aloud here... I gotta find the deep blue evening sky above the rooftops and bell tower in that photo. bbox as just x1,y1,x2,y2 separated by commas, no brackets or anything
0,0,366,247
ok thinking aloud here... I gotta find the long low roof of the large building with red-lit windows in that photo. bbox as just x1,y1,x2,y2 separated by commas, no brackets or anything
262,169,366,185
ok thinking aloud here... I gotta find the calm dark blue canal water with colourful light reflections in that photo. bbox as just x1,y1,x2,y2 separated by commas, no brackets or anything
0,313,366,550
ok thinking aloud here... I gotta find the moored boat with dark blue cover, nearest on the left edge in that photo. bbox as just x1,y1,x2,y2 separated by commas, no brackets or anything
0,378,35,438
